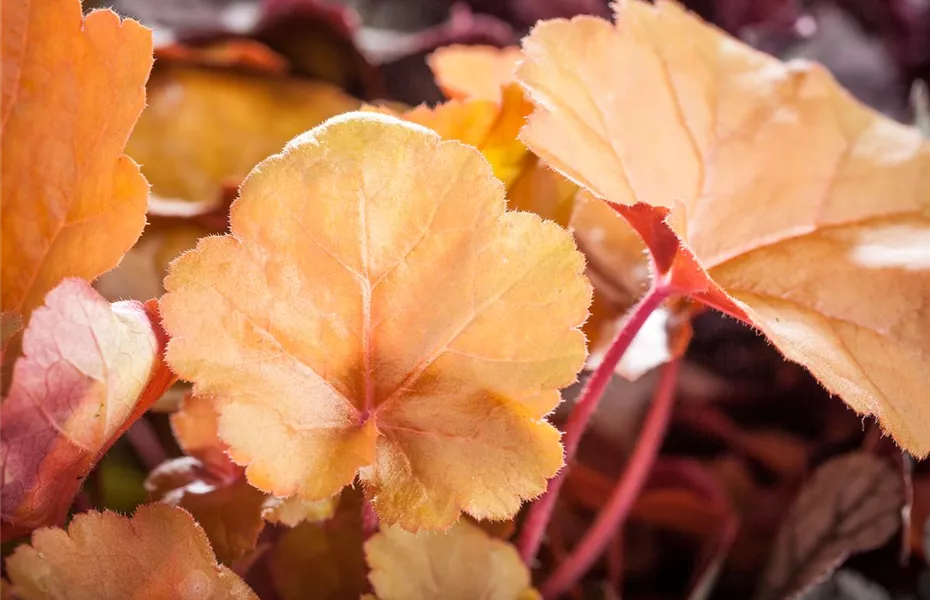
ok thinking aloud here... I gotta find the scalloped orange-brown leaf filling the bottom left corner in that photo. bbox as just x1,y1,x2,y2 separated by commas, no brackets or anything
6,504,258,600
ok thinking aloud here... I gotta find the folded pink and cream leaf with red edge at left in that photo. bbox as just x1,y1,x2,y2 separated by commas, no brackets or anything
0,279,174,540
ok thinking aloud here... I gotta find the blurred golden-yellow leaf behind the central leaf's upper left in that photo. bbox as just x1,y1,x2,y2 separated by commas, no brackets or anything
126,61,358,202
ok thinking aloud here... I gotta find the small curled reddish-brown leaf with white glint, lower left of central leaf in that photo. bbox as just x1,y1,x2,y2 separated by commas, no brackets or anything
145,458,265,565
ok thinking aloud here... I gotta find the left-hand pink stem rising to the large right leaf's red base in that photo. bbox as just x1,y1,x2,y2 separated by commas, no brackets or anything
517,280,672,566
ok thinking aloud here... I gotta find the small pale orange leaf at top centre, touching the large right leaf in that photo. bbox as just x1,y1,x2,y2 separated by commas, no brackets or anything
426,45,520,102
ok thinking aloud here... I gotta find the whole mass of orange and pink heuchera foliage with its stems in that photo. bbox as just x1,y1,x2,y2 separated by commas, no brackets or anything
0,0,930,600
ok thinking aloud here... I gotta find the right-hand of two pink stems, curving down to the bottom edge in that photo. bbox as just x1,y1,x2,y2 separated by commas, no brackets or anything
541,358,681,598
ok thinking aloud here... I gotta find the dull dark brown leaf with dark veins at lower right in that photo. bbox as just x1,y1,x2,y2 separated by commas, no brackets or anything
755,453,904,600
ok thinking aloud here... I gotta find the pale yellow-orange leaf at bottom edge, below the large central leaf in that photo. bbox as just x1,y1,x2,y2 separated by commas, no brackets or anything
365,520,538,600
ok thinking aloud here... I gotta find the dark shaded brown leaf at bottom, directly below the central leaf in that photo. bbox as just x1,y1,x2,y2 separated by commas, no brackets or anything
268,491,367,600
